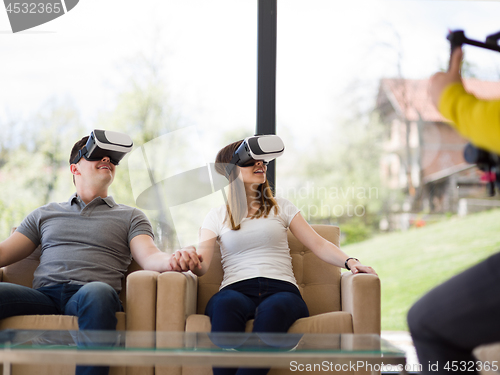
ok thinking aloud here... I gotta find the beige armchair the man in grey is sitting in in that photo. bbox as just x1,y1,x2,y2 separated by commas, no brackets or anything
0,228,158,375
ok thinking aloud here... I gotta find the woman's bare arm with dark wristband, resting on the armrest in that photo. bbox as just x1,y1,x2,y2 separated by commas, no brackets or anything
290,213,377,275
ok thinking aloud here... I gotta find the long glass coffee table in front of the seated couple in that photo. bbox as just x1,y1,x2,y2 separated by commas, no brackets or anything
0,330,406,375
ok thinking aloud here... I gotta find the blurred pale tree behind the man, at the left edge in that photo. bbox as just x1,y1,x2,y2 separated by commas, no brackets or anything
0,99,82,238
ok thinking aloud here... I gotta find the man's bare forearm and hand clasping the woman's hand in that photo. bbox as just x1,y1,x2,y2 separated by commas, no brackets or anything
130,234,201,272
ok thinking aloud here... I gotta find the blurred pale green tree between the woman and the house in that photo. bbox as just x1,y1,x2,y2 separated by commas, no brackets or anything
278,115,388,242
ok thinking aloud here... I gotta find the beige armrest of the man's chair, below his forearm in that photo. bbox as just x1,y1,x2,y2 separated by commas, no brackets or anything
126,271,159,331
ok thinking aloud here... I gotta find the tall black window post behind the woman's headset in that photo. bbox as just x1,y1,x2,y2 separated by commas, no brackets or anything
256,0,277,190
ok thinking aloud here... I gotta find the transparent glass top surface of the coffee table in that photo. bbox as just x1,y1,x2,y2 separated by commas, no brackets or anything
0,329,405,357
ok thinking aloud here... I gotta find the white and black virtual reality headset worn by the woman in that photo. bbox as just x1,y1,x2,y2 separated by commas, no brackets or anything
226,135,285,175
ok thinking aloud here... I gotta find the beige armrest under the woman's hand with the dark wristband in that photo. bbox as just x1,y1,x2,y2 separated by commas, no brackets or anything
340,272,381,335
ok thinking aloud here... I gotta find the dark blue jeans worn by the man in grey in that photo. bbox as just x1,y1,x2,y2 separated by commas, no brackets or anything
0,281,123,375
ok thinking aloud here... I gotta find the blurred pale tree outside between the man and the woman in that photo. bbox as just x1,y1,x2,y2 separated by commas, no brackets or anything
98,55,187,251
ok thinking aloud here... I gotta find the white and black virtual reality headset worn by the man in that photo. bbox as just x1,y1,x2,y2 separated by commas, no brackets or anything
71,129,133,165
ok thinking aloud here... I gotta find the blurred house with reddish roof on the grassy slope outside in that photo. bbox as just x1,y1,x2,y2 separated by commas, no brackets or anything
376,79,500,223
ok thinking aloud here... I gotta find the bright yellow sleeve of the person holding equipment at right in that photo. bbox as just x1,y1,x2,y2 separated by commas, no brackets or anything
439,83,500,154
